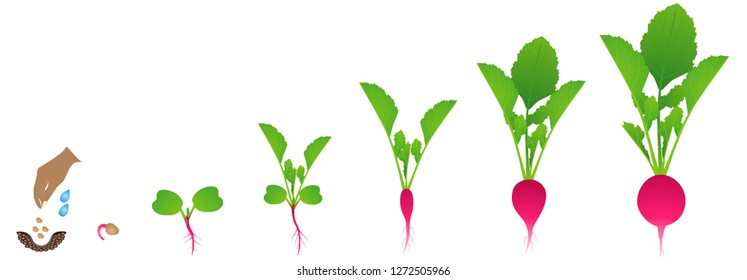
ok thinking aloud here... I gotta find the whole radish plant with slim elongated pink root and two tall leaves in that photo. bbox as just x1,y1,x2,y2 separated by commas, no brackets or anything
361,83,456,253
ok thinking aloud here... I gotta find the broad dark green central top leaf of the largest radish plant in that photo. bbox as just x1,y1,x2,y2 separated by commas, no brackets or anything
641,4,697,90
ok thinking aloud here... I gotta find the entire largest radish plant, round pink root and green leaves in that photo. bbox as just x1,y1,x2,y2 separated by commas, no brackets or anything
602,4,727,255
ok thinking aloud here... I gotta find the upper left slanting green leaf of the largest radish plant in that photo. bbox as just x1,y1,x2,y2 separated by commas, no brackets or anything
602,35,648,96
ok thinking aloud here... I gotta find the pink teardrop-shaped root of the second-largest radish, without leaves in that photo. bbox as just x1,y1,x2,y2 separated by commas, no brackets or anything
511,179,547,252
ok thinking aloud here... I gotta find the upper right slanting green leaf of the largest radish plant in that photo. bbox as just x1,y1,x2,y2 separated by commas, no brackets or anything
682,56,728,114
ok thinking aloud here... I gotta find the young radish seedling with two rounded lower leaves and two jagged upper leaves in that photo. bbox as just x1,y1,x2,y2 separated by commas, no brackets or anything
259,123,332,255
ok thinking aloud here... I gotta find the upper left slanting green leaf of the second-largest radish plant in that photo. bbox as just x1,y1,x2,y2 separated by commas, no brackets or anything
477,63,519,118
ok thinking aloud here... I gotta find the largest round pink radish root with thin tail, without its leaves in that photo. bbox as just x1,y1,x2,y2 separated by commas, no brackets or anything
638,175,685,256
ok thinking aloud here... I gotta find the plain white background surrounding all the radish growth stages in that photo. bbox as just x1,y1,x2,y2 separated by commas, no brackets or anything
0,1,747,279
